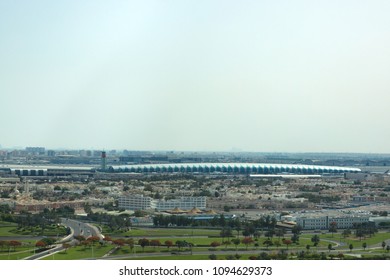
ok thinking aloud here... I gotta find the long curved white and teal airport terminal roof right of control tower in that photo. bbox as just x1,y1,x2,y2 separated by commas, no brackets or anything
109,163,361,174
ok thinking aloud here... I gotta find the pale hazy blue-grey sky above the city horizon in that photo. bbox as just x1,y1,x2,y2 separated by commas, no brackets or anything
0,0,390,153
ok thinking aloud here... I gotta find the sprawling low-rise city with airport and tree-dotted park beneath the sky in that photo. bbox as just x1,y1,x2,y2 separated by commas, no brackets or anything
0,147,390,259
